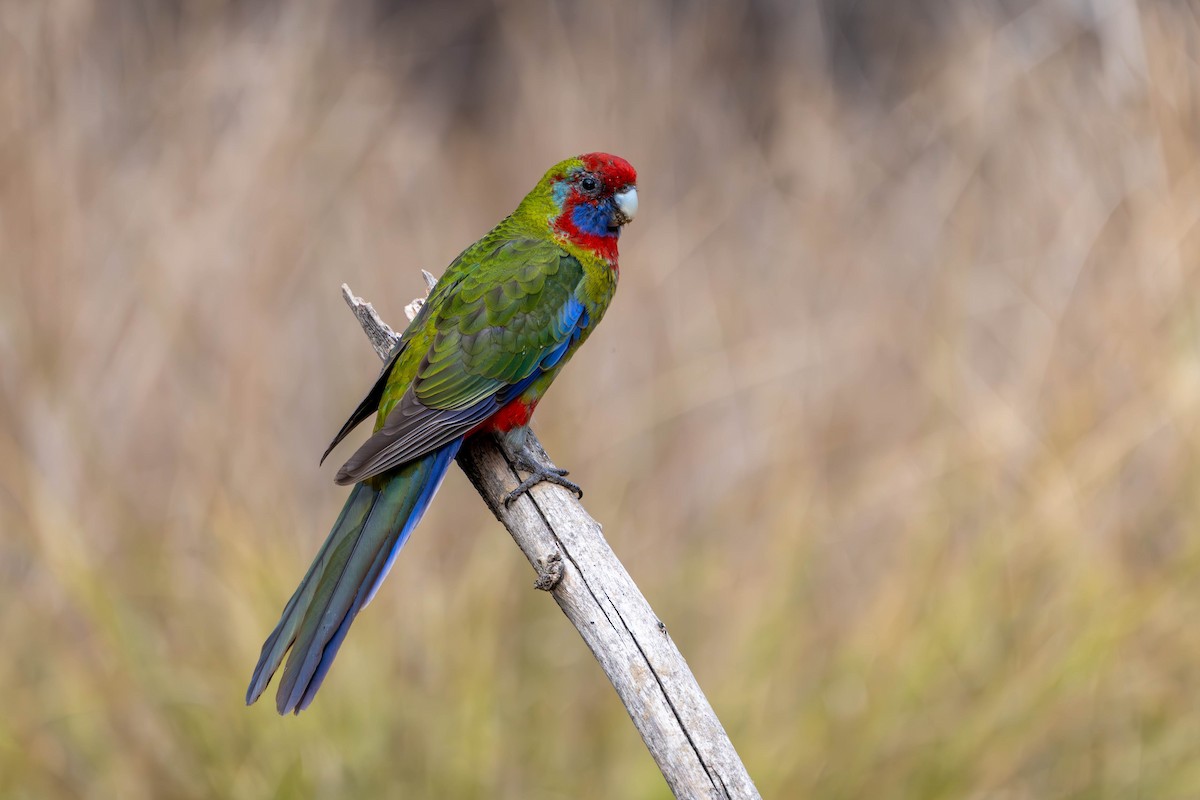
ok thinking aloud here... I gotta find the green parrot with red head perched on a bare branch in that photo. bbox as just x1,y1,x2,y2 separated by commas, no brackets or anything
246,152,637,715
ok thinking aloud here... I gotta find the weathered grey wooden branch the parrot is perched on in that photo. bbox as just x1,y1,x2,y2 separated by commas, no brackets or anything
342,284,760,800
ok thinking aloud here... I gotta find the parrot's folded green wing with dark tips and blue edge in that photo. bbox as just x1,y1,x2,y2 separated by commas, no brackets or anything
337,237,583,483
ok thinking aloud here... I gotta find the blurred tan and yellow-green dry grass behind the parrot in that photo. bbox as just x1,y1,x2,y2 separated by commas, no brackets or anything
0,0,1200,800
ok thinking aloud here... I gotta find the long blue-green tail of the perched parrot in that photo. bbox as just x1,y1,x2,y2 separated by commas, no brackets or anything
246,439,462,714
